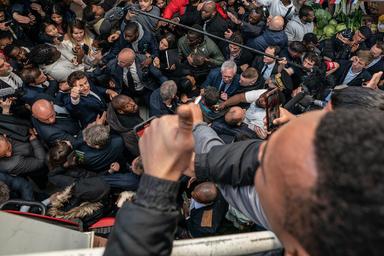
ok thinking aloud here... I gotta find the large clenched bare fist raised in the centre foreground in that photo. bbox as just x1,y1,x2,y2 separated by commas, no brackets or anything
139,105,194,181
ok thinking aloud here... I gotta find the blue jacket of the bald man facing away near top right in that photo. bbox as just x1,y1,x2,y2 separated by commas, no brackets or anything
247,29,288,51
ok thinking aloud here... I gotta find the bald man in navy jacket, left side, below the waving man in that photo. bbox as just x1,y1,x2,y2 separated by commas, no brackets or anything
32,99,82,147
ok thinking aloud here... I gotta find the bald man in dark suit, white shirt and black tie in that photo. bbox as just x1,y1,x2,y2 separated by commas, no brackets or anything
104,48,157,97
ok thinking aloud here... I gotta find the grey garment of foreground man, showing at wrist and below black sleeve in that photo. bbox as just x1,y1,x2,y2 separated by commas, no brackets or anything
193,123,270,229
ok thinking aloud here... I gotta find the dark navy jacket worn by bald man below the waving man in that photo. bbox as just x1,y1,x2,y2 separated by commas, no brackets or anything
32,113,82,148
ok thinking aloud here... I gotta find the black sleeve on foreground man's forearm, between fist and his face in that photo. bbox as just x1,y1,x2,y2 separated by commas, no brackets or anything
195,140,260,186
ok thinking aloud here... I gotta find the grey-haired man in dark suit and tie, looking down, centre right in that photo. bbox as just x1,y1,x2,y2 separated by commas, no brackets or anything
202,60,240,100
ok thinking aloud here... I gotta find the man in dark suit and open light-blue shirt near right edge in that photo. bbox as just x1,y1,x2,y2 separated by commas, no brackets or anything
334,50,372,86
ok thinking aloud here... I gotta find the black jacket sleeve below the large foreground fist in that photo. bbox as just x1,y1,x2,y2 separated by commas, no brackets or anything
104,175,179,255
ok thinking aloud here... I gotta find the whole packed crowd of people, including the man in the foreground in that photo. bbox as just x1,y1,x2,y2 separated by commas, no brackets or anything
0,0,384,255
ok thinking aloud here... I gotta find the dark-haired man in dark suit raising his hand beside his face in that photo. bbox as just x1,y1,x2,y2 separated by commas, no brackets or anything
64,71,117,127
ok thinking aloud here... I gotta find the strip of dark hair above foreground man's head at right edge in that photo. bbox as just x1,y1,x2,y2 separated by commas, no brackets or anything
331,86,384,110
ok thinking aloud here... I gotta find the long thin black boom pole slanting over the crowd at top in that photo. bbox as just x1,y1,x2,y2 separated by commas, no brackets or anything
123,6,307,70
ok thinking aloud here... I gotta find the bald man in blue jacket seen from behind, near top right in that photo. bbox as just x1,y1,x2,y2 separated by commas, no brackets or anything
247,16,288,52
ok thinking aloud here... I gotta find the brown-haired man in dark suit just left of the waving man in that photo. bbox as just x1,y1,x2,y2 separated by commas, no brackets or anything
20,67,59,105
